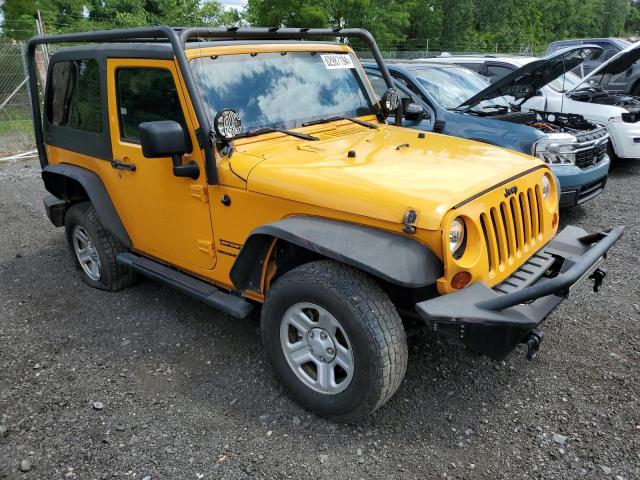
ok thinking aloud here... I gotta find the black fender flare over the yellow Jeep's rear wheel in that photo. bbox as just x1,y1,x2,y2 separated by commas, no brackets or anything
42,163,131,247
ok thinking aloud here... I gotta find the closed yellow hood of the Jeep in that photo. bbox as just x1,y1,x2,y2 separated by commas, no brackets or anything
231,124,542,230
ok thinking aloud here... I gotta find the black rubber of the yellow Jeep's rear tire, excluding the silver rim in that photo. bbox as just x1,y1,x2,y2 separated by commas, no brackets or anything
64,202,136,292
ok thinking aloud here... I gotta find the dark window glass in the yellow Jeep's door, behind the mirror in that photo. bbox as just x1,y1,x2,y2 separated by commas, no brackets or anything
116,68,188,143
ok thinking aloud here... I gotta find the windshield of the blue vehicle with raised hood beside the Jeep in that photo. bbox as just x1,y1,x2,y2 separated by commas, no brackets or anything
412,66,509,110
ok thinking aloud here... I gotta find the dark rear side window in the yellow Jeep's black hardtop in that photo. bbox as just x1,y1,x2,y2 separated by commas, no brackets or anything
47,60,102,133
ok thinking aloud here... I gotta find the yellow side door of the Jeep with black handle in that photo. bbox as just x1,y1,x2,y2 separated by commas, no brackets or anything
107,59,216,273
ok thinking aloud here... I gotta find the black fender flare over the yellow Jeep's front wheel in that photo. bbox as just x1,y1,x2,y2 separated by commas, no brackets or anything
230,216,443,292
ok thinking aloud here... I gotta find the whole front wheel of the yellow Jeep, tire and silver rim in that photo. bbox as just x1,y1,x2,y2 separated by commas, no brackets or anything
262,260,407,422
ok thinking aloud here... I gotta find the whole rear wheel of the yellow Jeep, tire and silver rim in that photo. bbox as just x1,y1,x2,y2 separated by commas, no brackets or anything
65,202,135,291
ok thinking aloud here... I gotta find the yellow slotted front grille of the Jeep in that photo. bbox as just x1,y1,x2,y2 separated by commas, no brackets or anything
480,186,544,273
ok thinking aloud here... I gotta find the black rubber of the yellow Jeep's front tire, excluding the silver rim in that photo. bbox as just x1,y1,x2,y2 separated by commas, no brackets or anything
261,260,408,422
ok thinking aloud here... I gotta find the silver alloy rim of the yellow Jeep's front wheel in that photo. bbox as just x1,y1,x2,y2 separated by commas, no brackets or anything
280,302,355,395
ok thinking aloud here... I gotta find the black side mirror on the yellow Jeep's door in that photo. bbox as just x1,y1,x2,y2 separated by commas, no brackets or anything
138,120,200,180
